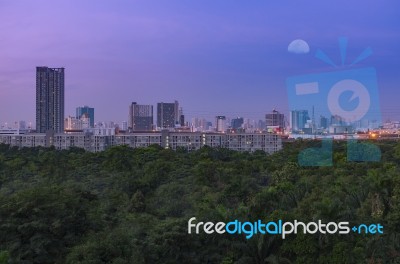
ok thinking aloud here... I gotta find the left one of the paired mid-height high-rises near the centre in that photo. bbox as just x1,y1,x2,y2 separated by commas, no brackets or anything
128,102,153,131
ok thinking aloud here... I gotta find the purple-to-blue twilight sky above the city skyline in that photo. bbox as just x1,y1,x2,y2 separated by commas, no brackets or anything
0,0,400,126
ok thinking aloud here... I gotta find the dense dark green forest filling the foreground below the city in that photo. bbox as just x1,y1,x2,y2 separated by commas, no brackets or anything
0,140,400,264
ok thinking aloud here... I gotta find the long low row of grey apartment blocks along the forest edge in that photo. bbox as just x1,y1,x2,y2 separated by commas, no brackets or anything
0,129,282,154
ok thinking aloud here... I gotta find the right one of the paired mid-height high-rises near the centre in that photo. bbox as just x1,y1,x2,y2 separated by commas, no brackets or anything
157,101,180,128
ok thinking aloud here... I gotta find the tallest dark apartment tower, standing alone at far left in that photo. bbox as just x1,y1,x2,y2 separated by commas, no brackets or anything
36,67,64,133
